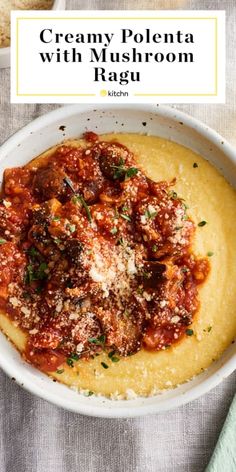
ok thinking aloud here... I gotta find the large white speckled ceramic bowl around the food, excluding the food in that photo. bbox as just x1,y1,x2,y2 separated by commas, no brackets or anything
0,105,236,417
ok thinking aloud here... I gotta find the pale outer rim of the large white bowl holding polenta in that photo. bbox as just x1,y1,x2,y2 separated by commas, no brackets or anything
0,103,236,418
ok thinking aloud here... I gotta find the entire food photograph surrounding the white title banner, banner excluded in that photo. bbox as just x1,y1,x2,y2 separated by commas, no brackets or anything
0,0,236,472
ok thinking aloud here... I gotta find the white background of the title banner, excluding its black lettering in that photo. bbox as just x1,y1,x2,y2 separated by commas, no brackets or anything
12,11,224,103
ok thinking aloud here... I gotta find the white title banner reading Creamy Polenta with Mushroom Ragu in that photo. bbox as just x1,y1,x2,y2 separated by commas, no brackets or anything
11,10,225,103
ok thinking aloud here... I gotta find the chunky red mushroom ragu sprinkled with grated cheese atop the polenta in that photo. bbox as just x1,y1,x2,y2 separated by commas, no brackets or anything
0,132,209,371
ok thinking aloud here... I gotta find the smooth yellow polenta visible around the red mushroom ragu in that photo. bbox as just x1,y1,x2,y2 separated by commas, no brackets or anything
0,134,236,398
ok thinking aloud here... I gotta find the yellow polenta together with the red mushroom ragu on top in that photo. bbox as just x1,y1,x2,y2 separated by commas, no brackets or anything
0,132,236,398
